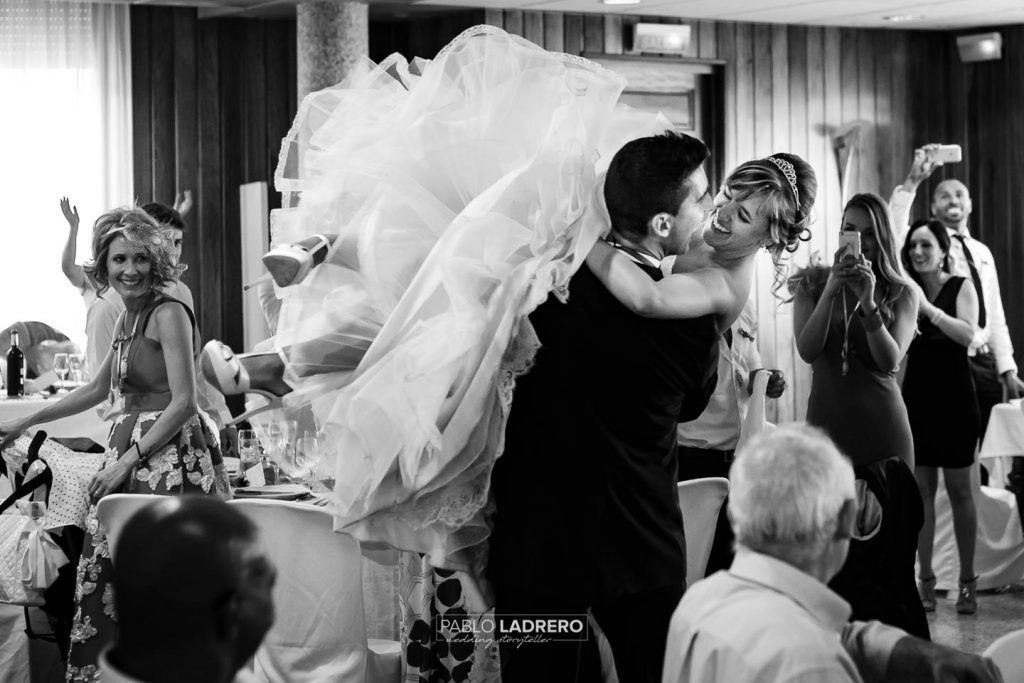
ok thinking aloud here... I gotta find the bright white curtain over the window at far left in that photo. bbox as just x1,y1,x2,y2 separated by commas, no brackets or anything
0,0,132,348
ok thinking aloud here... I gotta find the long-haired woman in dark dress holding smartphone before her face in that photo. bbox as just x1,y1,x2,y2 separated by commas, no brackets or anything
791,194,928,637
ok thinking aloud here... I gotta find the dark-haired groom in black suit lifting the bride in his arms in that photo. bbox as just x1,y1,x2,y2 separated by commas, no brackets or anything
487,132,718,683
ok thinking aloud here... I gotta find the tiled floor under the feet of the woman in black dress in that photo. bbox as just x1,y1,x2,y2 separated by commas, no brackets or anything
928,585,1024,653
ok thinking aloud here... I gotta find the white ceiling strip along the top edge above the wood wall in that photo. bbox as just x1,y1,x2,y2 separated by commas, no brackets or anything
113,0,1024,30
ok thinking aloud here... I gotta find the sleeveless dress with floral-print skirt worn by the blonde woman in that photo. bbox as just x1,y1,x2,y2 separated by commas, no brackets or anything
67,296,230,682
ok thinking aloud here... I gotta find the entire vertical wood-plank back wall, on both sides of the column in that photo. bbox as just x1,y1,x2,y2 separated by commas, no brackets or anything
132,6,1007,421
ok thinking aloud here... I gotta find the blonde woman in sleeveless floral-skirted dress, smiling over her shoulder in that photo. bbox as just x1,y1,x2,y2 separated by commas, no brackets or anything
0,209,229,681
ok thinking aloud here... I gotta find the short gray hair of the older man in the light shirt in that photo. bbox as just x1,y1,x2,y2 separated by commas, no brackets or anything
729,424,856,558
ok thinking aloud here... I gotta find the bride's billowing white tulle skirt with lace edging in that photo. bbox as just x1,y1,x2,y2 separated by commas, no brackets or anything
260,27,671,569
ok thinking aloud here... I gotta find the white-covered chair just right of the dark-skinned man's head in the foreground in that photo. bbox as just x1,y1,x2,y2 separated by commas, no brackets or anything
230,500,401,683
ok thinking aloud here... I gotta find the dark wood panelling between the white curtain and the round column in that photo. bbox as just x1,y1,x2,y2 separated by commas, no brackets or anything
131,6,297,348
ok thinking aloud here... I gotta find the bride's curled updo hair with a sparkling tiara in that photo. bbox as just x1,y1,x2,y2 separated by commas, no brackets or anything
724,152,818,268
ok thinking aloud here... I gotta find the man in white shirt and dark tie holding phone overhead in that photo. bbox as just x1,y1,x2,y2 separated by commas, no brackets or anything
889,144,1024,434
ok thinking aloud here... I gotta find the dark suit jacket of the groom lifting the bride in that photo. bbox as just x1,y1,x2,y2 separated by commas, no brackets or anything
487,259,718,604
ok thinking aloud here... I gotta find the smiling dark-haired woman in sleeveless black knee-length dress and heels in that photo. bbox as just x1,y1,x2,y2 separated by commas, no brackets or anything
902,220,981,614
